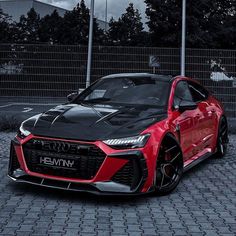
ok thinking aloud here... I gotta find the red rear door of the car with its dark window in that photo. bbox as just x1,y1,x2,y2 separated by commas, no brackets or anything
188,81,217,152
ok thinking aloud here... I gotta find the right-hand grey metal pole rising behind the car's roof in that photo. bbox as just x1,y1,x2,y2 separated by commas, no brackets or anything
181,0,186,76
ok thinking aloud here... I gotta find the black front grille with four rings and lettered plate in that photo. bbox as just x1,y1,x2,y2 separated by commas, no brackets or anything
23,139,106,180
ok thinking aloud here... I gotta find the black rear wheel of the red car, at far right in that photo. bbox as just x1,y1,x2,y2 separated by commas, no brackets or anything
216,117,229,158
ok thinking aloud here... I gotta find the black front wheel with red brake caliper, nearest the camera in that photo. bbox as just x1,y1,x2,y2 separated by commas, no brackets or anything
155,138,183,195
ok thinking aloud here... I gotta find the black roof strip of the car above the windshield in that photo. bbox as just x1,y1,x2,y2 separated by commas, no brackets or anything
103,73,174,82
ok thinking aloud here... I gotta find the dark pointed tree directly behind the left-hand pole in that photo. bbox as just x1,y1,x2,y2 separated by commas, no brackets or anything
60,0,104,44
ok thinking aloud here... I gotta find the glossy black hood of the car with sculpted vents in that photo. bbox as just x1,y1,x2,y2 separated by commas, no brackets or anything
23,104,167,141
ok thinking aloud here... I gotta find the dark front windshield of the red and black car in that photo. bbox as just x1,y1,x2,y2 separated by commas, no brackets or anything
77,77,169,106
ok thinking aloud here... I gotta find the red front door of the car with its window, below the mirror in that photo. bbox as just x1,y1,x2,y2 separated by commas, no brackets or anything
173,81,200,161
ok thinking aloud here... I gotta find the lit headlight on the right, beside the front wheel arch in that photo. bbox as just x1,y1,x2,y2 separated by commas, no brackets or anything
103,134,150,149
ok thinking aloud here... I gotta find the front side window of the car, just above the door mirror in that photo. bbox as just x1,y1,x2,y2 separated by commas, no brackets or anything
174,81,193,107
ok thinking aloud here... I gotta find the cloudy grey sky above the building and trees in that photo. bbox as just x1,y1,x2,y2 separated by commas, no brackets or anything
39,0,146,21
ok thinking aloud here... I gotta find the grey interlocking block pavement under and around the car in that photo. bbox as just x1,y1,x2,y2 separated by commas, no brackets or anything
0,133,236,236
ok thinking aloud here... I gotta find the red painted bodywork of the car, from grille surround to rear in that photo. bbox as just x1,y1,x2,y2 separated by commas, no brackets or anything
10,77,224,192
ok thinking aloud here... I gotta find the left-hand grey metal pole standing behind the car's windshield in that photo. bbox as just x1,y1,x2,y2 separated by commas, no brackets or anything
86,0,94,88
